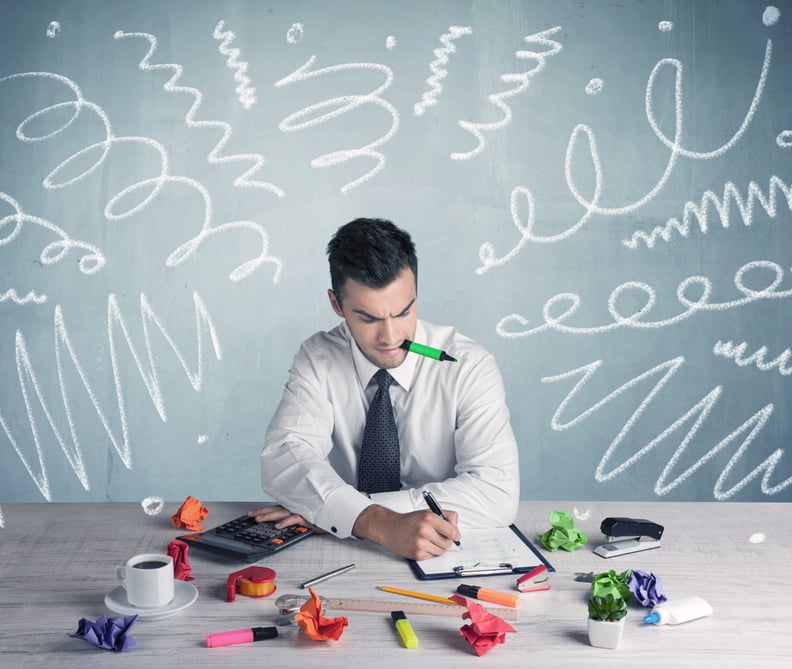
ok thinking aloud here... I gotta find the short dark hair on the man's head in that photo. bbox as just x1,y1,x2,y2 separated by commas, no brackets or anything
327,218,418,303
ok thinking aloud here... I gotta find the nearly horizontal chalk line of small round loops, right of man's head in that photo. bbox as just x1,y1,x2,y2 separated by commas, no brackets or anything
495,260,792,339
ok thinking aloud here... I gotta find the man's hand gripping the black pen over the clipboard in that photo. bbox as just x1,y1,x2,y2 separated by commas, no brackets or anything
352,504,460,560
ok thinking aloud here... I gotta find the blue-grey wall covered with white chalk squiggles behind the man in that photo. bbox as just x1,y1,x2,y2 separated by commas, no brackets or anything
0,0,792,508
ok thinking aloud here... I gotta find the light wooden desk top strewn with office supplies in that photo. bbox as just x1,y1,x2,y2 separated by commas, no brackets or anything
0,502,792,669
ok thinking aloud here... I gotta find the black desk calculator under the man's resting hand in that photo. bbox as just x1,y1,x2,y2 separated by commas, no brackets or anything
177,516,313,562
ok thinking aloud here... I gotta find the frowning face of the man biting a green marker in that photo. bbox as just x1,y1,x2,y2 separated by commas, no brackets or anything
328,268,417,369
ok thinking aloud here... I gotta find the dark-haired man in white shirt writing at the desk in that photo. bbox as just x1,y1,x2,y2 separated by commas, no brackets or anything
249,219,519,560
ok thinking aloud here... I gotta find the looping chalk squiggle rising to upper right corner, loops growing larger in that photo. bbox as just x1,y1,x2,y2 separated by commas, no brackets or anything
476,40,773,274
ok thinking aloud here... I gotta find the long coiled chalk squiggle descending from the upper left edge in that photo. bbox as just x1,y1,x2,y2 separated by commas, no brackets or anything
0,72,282,283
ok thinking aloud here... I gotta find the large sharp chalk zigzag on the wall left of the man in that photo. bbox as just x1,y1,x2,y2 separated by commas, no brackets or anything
0,292,222,501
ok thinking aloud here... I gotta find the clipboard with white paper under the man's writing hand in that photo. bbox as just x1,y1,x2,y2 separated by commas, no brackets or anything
408,525,555,581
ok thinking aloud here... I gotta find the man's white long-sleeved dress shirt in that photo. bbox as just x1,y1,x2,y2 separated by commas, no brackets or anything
261,320,520,538
